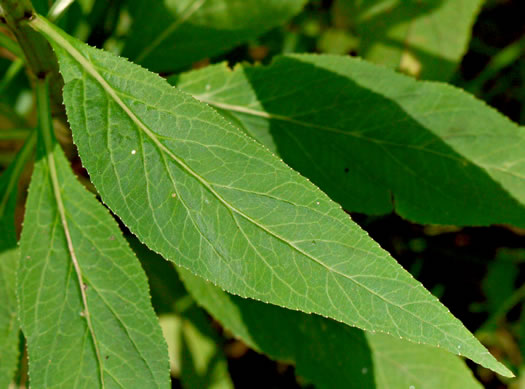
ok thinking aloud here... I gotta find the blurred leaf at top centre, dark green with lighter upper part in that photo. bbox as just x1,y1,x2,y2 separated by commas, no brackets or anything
122,0,306,72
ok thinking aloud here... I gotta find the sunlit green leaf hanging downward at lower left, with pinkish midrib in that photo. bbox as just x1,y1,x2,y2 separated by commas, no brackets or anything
18,77,169,389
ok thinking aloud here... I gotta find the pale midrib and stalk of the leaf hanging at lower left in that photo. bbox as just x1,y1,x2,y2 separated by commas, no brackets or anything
36,76,105,388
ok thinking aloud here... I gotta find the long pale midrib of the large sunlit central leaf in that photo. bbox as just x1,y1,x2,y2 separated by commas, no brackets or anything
32,18,476,345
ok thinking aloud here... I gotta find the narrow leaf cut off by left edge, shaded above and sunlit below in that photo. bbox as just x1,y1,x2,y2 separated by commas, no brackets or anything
0,132,36,388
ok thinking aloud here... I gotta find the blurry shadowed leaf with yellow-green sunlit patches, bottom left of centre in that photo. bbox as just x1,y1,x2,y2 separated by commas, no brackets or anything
133,238,233,389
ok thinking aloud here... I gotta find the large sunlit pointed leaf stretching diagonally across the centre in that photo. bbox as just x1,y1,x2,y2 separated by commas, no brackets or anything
32,18,510,374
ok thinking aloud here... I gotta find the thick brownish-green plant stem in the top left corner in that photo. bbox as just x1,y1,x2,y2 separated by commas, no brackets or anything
0,0,63,113
